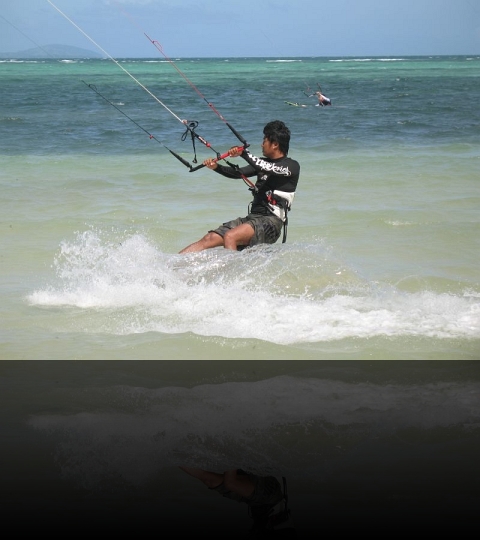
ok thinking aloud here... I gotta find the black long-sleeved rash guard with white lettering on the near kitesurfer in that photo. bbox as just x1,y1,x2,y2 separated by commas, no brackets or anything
215,150,300,216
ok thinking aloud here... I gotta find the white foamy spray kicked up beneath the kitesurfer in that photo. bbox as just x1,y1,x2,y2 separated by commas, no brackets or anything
27,231,480,344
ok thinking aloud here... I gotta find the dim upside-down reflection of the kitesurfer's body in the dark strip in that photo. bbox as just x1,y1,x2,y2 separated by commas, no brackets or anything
180,467,296,538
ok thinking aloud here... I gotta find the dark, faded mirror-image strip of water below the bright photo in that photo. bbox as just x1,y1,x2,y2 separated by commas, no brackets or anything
0,361,480,539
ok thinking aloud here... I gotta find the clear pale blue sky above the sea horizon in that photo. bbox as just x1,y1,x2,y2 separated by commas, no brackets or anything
0,0,480,58
